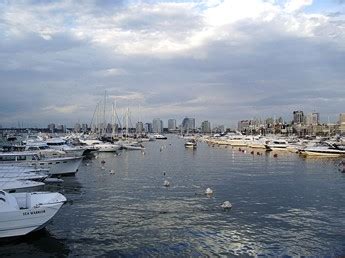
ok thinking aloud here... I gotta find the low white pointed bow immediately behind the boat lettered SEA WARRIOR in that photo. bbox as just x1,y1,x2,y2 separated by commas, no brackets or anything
0,178,44,193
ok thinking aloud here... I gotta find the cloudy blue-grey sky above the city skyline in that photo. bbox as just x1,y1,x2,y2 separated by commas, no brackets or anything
0,0,345,127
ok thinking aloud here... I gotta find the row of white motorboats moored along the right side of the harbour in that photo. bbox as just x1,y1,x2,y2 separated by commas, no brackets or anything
201,133,345,157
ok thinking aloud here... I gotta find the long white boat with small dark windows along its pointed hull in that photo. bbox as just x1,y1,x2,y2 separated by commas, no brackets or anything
0,152,83,175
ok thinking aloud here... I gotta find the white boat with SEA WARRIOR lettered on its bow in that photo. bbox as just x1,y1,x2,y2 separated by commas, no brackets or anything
0,191,66,238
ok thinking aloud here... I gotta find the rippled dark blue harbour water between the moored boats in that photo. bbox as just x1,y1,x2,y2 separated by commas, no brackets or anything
0,136,345,257
